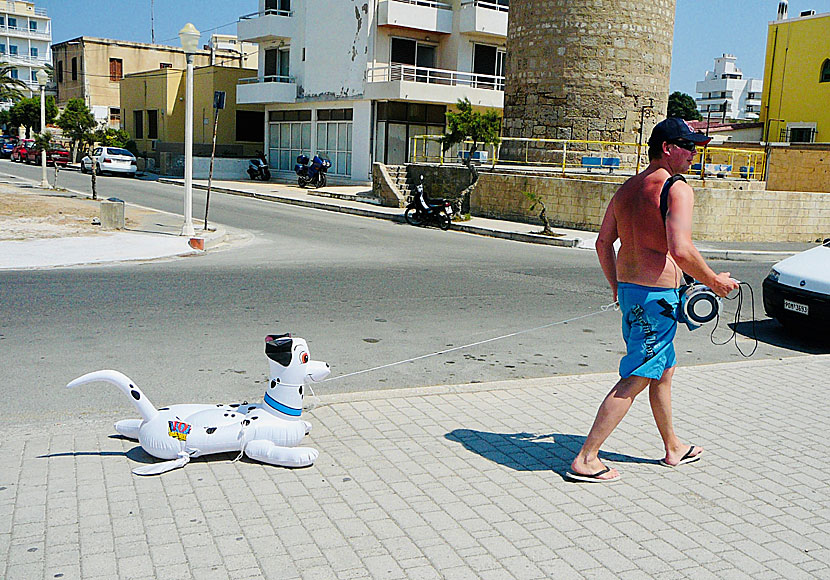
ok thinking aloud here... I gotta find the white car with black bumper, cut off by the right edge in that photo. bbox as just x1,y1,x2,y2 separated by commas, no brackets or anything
764,239,830,332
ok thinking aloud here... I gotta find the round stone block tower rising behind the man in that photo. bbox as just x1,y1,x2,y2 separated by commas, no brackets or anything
502,0,675,150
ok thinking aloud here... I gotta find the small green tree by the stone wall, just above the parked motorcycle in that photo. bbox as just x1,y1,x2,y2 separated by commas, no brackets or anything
441,98,501,214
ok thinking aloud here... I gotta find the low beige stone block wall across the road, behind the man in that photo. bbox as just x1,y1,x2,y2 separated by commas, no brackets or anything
409,165,830,242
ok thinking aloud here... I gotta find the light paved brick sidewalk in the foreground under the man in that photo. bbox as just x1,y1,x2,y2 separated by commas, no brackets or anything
0,355,830,580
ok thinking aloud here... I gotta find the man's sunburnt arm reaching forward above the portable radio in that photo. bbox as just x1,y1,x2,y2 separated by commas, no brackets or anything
666,181,738,296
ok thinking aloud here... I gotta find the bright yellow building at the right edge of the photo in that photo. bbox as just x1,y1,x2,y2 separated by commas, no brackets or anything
761,12,830,143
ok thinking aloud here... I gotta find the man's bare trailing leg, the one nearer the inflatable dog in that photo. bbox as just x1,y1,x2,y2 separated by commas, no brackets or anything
571,376,650,479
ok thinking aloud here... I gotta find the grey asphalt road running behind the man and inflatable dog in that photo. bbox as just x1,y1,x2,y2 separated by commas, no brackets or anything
0,160,828,420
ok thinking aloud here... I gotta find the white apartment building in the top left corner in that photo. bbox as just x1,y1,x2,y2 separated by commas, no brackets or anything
0,0,52,96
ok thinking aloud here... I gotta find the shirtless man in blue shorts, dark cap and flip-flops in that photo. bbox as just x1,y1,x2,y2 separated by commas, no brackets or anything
566,117,738,483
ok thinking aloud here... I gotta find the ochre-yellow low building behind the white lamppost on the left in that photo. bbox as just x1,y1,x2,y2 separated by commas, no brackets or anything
120,66,265,165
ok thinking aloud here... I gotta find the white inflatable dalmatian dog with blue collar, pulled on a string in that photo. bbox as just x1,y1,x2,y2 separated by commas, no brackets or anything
66,334,330,475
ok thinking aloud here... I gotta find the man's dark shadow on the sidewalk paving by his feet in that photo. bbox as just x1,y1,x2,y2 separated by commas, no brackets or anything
444,429,659,478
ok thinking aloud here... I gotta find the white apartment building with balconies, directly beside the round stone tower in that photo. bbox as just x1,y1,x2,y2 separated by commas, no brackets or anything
237,0,509,181
